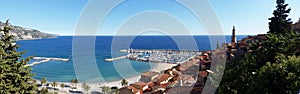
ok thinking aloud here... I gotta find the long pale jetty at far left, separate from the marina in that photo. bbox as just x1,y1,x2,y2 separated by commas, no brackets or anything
25,57,70,67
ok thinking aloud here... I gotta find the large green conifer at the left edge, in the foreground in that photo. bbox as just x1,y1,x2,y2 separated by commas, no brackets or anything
0,20,37,94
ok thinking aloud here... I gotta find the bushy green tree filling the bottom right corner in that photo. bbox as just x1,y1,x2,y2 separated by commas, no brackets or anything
249,54,300,94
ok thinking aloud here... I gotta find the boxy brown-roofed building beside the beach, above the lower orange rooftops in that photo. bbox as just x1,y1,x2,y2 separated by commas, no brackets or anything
141,71,159,83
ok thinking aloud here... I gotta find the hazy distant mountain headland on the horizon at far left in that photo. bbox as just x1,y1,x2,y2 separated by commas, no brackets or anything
0,21,57,40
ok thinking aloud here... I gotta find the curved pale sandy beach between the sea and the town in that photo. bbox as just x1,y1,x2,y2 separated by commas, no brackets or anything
32,48,201,93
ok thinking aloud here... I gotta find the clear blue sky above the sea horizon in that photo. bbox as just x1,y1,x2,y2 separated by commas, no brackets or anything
0,0,300,35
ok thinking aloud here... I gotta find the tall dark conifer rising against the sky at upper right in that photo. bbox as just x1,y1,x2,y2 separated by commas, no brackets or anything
268,0,292,34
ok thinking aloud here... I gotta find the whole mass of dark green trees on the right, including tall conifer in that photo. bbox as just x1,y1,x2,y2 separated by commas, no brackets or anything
217,0,300,94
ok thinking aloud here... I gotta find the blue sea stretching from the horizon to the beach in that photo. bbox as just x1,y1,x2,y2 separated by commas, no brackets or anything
17,35,245,82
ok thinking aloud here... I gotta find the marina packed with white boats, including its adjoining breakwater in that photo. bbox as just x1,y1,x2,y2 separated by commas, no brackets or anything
105,49,202,64
